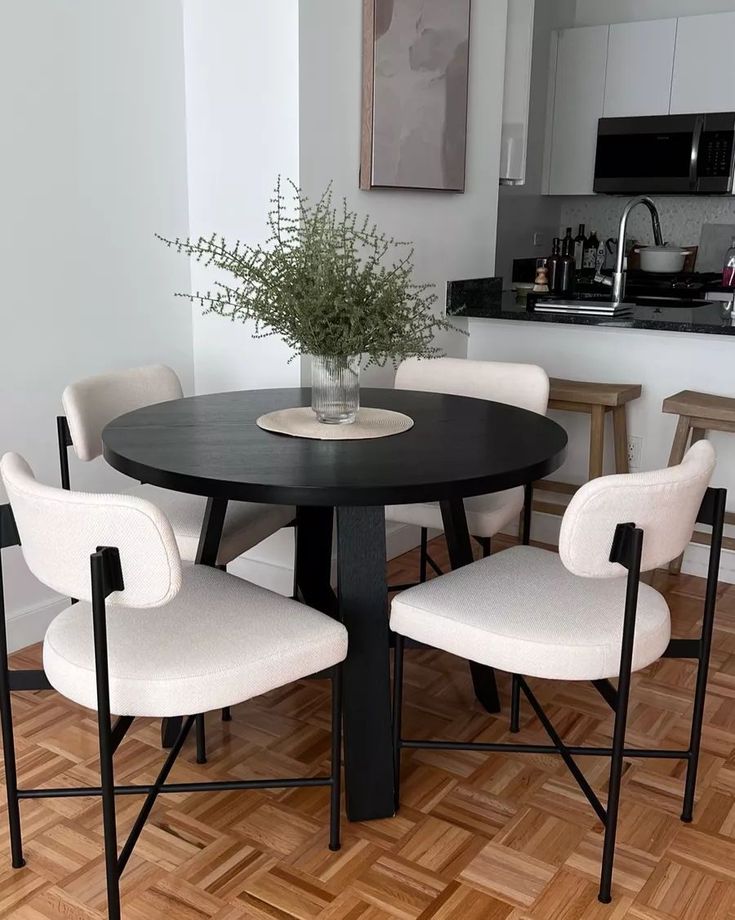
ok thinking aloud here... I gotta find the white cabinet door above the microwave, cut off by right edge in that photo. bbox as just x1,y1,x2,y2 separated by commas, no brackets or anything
671,13,735,115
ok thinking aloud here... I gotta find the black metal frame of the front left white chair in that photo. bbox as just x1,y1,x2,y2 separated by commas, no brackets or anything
0,504,342,920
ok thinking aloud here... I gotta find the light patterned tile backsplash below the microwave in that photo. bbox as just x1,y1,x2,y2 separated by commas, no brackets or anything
561,195,735,246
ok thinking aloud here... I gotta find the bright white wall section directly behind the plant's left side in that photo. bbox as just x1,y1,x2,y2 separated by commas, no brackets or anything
184,0,299,393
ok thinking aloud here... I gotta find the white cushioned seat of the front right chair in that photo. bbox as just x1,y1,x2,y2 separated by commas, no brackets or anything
391,546,671,680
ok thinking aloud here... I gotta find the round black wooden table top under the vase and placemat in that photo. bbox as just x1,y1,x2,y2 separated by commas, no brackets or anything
102,388,567,506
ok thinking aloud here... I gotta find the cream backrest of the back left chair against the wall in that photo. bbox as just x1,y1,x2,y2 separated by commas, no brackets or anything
61,364,184,460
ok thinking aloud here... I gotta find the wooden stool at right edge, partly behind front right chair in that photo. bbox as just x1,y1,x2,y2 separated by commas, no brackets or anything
662,390,735,575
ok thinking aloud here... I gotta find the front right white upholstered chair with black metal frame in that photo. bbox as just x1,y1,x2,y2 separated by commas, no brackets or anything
391,441,725,902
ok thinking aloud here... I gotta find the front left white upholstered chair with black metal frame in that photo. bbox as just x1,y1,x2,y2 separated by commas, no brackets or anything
0,454,347,920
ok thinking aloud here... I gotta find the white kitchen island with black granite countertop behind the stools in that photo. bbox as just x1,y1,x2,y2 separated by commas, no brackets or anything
447,282,735,583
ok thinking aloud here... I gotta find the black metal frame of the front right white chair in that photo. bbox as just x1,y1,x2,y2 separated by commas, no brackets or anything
393,488,727,904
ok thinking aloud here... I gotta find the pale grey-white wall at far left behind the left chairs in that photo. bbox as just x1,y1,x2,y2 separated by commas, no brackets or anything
0,0,192,646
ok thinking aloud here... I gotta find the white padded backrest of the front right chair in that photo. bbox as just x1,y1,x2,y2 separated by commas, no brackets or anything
559,441,715,578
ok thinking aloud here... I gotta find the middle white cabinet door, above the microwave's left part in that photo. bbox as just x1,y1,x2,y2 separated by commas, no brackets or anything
604,19,676,118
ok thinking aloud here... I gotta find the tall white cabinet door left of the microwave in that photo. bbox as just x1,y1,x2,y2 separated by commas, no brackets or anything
549,26,610,195
